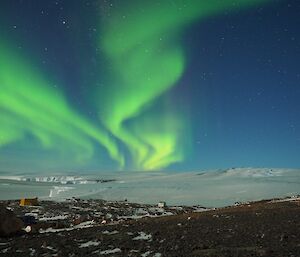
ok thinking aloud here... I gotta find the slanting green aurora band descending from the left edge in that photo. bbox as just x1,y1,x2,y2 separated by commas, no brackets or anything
0,40,123,164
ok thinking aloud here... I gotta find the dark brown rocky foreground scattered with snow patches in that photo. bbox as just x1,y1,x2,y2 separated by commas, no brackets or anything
0,198,300,254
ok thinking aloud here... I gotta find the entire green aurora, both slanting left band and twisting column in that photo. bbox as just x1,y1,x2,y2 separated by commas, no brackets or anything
0,0,264,170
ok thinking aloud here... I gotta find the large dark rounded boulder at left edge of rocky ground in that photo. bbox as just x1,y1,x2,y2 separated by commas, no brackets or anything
0,205,24,236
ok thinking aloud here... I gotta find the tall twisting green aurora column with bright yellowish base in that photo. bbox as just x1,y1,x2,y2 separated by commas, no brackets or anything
99,0,268,170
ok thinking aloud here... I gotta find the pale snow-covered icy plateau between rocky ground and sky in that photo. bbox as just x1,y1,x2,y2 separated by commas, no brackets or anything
0,168,300,207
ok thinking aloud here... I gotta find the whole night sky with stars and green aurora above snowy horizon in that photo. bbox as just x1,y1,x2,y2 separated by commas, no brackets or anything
0,0,300,172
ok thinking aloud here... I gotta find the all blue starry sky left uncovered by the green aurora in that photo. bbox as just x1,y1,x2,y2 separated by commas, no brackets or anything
0,0,300,170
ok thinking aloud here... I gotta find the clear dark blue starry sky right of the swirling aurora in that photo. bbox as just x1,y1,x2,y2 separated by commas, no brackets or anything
176,1,300,169
